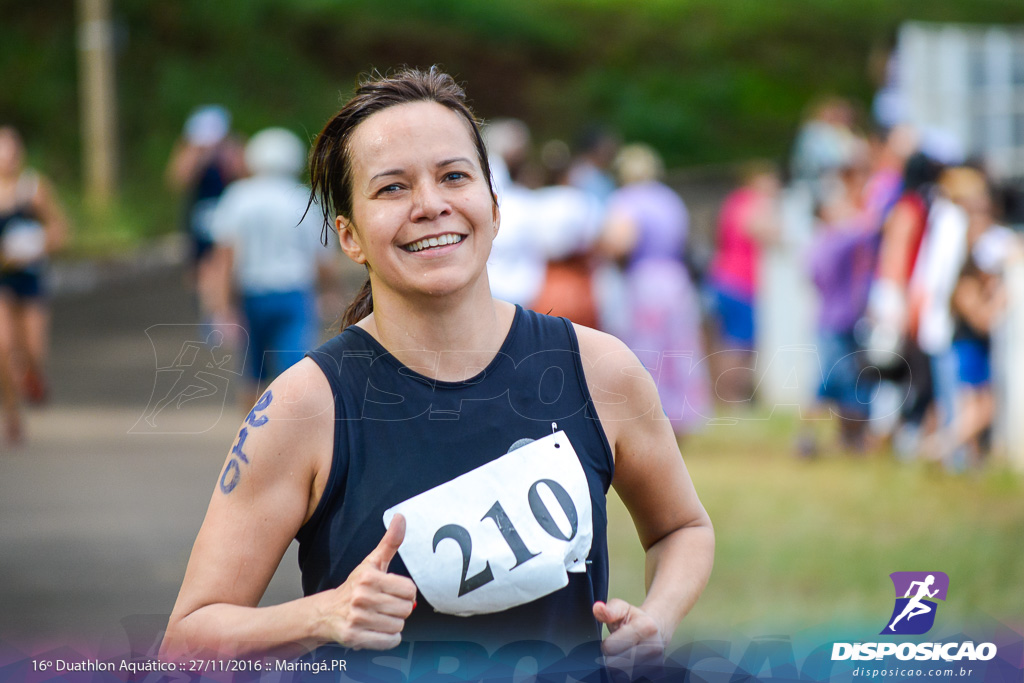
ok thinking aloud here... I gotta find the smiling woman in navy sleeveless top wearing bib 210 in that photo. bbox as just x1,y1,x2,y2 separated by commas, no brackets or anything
163,69,714,676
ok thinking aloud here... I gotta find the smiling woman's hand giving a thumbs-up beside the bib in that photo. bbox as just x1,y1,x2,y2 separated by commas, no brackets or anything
318,515,416,650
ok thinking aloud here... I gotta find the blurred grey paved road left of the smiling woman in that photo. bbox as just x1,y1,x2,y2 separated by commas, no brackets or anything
0,266,311,649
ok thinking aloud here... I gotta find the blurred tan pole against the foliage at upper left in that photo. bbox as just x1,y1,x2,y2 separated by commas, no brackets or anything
77,0,118,210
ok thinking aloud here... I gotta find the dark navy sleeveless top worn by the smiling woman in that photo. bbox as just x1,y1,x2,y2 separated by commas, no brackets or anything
296,306,612,651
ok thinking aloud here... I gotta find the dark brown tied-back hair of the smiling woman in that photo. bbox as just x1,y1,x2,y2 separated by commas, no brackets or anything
306,67,495,329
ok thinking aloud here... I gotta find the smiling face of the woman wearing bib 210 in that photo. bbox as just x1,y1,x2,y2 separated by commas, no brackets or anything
336,101,498,299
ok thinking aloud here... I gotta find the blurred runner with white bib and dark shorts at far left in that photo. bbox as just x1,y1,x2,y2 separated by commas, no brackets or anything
0,126,68,442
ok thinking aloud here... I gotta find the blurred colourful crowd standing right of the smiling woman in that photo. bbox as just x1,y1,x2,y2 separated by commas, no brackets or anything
475,85,1024,470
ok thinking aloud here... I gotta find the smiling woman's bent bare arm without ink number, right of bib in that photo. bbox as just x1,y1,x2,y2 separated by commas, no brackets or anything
577,328,715,654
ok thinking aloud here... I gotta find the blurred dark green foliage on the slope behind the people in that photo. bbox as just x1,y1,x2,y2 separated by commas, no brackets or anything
0,0,1024,245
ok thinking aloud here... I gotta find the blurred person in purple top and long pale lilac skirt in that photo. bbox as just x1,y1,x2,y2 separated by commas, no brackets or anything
601,144,711,435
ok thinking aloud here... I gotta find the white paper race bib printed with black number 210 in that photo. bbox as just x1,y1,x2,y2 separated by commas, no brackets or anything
384,431,594,616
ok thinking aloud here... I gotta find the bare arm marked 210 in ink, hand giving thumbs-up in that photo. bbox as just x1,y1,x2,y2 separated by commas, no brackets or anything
161,358,416,658
